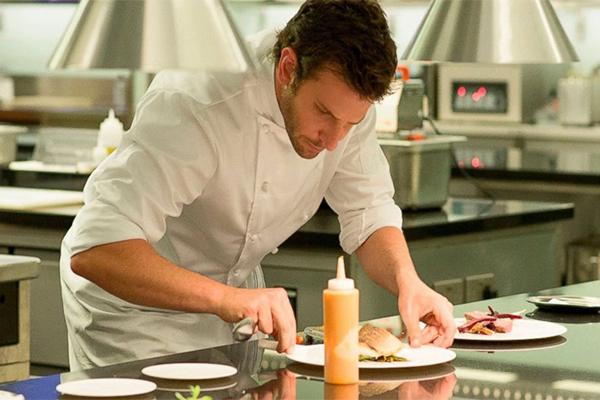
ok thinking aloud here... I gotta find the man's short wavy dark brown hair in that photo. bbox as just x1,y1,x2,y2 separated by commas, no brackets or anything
271,0,398,101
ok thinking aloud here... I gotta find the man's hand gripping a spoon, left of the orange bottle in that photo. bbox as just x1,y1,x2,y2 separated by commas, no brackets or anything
217,287,296,353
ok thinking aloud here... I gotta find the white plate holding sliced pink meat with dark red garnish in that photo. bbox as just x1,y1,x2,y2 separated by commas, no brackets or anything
454,318,567,342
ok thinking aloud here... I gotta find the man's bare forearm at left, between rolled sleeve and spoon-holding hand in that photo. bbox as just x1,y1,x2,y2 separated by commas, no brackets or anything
71,239,228,313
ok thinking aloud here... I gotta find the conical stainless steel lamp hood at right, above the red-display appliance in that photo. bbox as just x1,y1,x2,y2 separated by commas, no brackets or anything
402,0,579,64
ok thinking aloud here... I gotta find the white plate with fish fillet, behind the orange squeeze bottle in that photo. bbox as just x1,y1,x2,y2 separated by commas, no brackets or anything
287,344,456,369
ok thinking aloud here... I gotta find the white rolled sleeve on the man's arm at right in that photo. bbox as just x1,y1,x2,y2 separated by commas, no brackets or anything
325,107,402,254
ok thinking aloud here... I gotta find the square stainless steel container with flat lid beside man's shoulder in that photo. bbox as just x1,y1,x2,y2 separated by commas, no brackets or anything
379,136,466,210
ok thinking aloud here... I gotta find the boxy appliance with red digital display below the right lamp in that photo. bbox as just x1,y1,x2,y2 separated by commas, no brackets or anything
437,64,568,123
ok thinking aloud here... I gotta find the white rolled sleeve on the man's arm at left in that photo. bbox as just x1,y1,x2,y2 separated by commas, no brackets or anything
70,90,217,254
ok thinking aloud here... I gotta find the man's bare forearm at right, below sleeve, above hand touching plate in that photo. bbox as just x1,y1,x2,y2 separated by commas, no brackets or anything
356,227,418,296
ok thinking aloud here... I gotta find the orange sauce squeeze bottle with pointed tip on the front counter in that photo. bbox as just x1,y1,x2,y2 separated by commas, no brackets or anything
323,256,359,384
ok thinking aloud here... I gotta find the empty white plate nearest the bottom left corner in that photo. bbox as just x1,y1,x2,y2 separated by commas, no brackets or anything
56,378,156,397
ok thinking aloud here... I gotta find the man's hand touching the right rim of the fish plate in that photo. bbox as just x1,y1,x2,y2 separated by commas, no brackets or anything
398,277,456,347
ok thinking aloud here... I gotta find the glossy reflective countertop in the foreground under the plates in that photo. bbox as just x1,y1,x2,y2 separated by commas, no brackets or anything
0,282,600,400
